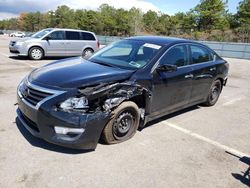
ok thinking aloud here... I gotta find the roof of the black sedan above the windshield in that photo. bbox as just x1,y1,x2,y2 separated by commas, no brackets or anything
126,36,196,45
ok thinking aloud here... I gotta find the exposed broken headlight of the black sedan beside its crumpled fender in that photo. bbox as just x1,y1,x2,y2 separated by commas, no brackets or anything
60,97,89,110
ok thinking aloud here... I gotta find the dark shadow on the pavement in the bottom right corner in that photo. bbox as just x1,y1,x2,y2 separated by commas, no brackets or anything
229,151,250,187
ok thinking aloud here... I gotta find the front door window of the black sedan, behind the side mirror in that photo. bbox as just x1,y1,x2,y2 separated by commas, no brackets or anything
160,45,188,67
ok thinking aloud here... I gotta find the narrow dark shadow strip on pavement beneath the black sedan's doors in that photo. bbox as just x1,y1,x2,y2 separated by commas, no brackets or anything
141,105,200,131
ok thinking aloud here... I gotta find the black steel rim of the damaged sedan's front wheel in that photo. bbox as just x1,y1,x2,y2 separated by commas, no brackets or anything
113,112,135,139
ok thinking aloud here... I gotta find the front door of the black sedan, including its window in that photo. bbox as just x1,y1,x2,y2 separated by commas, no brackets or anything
151,45,193,116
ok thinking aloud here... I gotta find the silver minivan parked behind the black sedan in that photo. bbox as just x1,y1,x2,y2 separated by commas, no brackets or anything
9,28,100,60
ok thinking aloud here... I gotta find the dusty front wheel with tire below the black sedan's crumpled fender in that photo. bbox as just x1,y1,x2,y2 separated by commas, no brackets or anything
102,101,140,144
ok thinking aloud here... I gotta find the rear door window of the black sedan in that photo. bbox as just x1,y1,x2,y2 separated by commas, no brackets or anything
190,45,212,64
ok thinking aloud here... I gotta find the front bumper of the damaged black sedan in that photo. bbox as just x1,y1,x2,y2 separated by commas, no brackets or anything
17,86,110,150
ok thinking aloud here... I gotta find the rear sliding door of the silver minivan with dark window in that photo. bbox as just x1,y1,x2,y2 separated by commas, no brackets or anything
65,31,83,56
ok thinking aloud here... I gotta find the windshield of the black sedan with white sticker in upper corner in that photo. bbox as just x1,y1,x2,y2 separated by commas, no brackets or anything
89,40,162,69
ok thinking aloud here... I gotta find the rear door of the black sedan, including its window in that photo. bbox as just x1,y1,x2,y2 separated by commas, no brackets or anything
189,44,216,103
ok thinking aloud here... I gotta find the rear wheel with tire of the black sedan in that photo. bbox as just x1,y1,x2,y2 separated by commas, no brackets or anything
204,80,222,106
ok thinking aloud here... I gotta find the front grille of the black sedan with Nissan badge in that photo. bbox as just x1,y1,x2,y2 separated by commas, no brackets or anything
20,84,53,106
